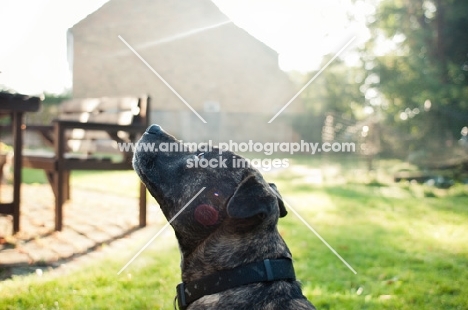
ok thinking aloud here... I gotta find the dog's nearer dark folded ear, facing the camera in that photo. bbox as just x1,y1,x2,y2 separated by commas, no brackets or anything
226,175,277,219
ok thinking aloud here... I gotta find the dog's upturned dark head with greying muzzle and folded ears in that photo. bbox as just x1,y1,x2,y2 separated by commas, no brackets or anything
133,125,287,253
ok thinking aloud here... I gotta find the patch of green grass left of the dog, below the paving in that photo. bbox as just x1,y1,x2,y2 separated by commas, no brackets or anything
0,242,179,310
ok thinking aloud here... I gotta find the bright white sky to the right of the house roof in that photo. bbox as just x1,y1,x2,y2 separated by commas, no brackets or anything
213,0,362,72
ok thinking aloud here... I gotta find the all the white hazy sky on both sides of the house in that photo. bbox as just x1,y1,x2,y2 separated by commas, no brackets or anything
0,0,371,94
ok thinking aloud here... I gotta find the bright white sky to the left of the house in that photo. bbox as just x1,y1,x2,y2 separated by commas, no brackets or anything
0,0,108,95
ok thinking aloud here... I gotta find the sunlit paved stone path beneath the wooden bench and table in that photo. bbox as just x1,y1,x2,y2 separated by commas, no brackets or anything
0,184,166,280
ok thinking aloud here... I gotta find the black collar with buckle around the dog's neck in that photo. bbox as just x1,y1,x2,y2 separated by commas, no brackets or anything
174,258,296,310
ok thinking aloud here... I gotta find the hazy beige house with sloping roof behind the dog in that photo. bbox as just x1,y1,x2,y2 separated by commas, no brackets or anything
68,0,301,142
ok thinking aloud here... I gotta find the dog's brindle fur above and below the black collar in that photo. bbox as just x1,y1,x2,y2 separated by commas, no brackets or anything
133,125,315,310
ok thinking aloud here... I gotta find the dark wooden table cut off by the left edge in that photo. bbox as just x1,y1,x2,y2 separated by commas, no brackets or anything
0,92,41,233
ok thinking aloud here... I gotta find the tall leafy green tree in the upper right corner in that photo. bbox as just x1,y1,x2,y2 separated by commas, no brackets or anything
362,0,468,159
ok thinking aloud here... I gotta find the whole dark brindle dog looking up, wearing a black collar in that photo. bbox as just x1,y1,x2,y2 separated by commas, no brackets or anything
133,125,315,310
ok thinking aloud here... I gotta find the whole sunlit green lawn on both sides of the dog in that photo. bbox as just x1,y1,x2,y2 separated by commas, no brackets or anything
0,159,468,310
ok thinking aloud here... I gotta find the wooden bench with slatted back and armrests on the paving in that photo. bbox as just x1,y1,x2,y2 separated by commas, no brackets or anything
23,97,150,230
